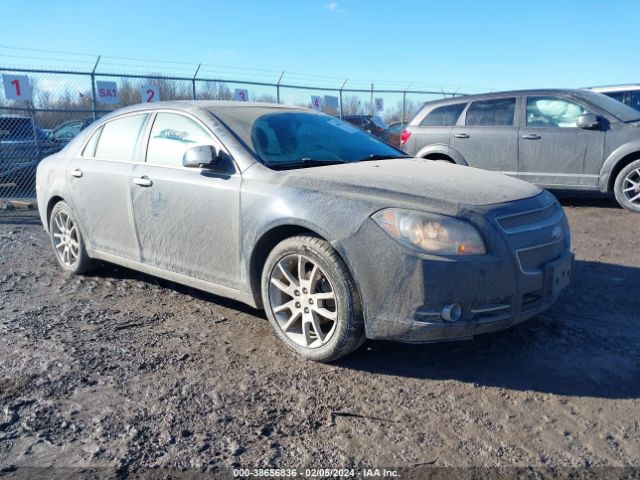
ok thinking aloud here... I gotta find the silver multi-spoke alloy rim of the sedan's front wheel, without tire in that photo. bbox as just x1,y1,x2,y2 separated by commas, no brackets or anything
269,255,338,348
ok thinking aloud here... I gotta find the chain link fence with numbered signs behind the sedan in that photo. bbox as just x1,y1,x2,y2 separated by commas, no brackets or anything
0,64,460,200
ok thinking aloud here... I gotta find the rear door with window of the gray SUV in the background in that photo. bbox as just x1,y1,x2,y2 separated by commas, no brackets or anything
451,97,518,176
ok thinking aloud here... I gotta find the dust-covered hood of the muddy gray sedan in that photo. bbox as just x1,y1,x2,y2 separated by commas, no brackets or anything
289,158,541,213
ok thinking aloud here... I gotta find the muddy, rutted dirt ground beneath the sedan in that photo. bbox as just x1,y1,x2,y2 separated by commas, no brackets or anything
0,193,640,477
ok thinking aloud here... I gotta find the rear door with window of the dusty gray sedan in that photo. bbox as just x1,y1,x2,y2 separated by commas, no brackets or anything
67,114,148,260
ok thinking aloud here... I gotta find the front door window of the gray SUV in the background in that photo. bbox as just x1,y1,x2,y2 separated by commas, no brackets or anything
527,97,588,128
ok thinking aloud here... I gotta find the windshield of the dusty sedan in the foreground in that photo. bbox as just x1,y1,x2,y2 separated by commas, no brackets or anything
212,107,407,168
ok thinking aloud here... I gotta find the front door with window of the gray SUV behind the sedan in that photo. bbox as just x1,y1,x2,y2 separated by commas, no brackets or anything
518,96,604,188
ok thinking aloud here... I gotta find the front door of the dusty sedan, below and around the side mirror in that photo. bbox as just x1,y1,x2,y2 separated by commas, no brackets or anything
131,112,240,288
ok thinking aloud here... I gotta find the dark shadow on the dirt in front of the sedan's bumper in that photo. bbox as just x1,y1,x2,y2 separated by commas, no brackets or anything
338,261,640,398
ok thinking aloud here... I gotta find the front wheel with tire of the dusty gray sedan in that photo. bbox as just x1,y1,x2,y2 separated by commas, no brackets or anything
262,235,366,362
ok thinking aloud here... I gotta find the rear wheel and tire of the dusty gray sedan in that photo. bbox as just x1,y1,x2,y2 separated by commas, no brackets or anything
49,201,96,274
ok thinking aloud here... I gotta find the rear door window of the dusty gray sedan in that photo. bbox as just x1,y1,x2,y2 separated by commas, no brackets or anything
89,114,147,162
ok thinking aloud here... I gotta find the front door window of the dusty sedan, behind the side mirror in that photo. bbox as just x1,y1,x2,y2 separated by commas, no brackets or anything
147,113,213,167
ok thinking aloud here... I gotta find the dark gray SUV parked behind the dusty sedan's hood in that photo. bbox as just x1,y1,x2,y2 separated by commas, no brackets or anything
402,89,640,212
